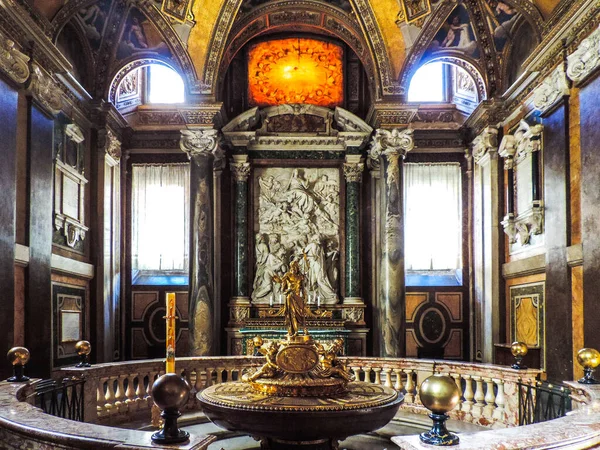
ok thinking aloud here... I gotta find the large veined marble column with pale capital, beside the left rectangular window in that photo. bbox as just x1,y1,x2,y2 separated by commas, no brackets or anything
180,129,221,356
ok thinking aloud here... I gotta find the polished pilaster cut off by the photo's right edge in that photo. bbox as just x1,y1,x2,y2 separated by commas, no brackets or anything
580,78,600,348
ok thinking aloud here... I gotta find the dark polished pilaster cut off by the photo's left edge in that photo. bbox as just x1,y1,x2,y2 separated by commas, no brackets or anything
0,80,18,378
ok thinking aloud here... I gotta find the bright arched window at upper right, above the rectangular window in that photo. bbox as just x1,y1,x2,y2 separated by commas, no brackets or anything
408,60,484,113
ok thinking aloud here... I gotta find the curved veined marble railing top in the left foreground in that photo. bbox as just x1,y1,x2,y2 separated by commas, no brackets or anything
0,381,215,450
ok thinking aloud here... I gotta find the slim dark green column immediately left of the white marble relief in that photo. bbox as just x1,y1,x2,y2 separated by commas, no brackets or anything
229,155,250,301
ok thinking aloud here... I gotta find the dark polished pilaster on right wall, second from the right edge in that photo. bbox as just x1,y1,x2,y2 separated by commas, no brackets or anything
543,103,573,380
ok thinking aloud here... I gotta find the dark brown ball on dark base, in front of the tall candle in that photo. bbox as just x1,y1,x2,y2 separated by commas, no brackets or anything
152,373,191,444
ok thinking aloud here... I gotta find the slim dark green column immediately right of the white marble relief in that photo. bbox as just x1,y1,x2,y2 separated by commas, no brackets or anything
344,155,365,305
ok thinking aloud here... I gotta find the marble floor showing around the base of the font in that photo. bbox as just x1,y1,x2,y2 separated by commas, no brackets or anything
126,411,486,450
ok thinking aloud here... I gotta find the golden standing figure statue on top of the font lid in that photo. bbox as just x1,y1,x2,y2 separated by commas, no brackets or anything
273,261,308,336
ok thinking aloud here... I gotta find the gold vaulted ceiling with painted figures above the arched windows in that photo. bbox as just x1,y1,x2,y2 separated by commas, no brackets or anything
21,0,559,99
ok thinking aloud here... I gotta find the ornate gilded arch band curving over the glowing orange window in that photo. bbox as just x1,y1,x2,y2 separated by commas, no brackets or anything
217,0,381,98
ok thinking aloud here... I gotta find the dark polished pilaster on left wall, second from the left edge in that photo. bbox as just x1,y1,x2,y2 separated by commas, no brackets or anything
25,104,54,377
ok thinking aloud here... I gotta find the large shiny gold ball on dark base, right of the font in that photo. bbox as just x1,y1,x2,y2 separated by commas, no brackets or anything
419,374,460,446
